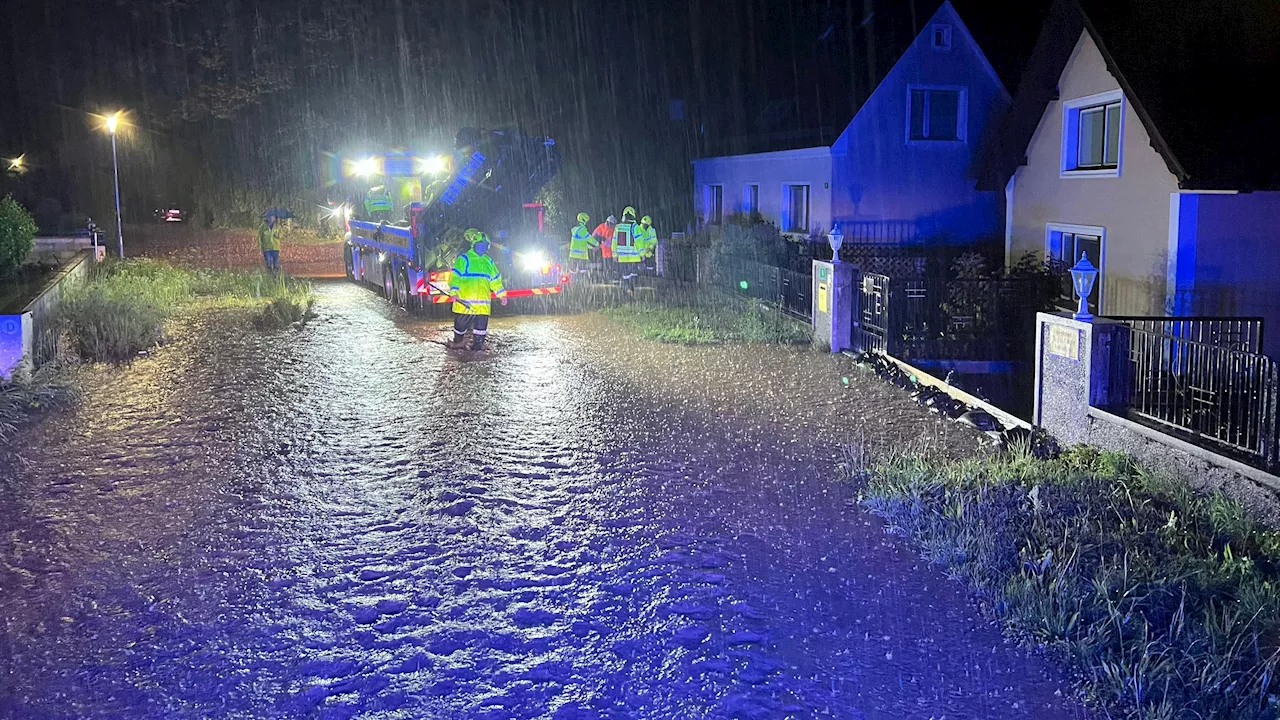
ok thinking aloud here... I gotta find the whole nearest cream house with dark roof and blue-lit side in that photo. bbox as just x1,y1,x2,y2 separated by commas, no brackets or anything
979,0,1280,348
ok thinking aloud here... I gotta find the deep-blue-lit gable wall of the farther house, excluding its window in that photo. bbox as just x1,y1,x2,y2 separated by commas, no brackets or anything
832,4,1010,245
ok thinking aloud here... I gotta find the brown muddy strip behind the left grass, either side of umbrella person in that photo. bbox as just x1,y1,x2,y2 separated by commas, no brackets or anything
124,223,346,278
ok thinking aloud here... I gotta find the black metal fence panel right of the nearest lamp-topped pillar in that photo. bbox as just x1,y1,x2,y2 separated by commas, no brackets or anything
1123,318,1280,470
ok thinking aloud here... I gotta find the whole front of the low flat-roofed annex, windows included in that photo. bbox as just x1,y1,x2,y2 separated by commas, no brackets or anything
694,147,831,236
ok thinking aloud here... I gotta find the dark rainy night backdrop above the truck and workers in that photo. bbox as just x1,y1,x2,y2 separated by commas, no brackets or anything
0,0,1047,227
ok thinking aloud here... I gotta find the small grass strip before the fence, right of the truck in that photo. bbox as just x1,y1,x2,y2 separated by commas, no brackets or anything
602,299,812,345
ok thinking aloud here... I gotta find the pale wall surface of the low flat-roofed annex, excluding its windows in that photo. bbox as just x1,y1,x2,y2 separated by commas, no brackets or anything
694,147,831,232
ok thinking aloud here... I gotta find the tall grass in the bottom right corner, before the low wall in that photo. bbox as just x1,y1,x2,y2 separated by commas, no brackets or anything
846,446,1280,720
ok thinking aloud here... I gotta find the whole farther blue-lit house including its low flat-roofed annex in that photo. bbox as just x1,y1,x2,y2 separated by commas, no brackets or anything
694,1,1010,243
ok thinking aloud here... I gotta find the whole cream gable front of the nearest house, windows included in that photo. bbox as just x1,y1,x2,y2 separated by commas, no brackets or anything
1006,31,1178,315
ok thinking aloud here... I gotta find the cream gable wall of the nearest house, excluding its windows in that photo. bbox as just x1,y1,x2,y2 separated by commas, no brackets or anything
1006,31,1178,315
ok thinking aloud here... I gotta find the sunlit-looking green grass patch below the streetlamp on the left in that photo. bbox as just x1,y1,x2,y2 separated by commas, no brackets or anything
60,259,311,363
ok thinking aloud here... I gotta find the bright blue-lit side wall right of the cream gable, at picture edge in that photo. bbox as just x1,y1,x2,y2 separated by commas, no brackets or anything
1166,192,1280,357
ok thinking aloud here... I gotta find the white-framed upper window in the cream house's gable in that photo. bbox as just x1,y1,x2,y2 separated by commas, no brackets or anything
1062,90,1124,177
